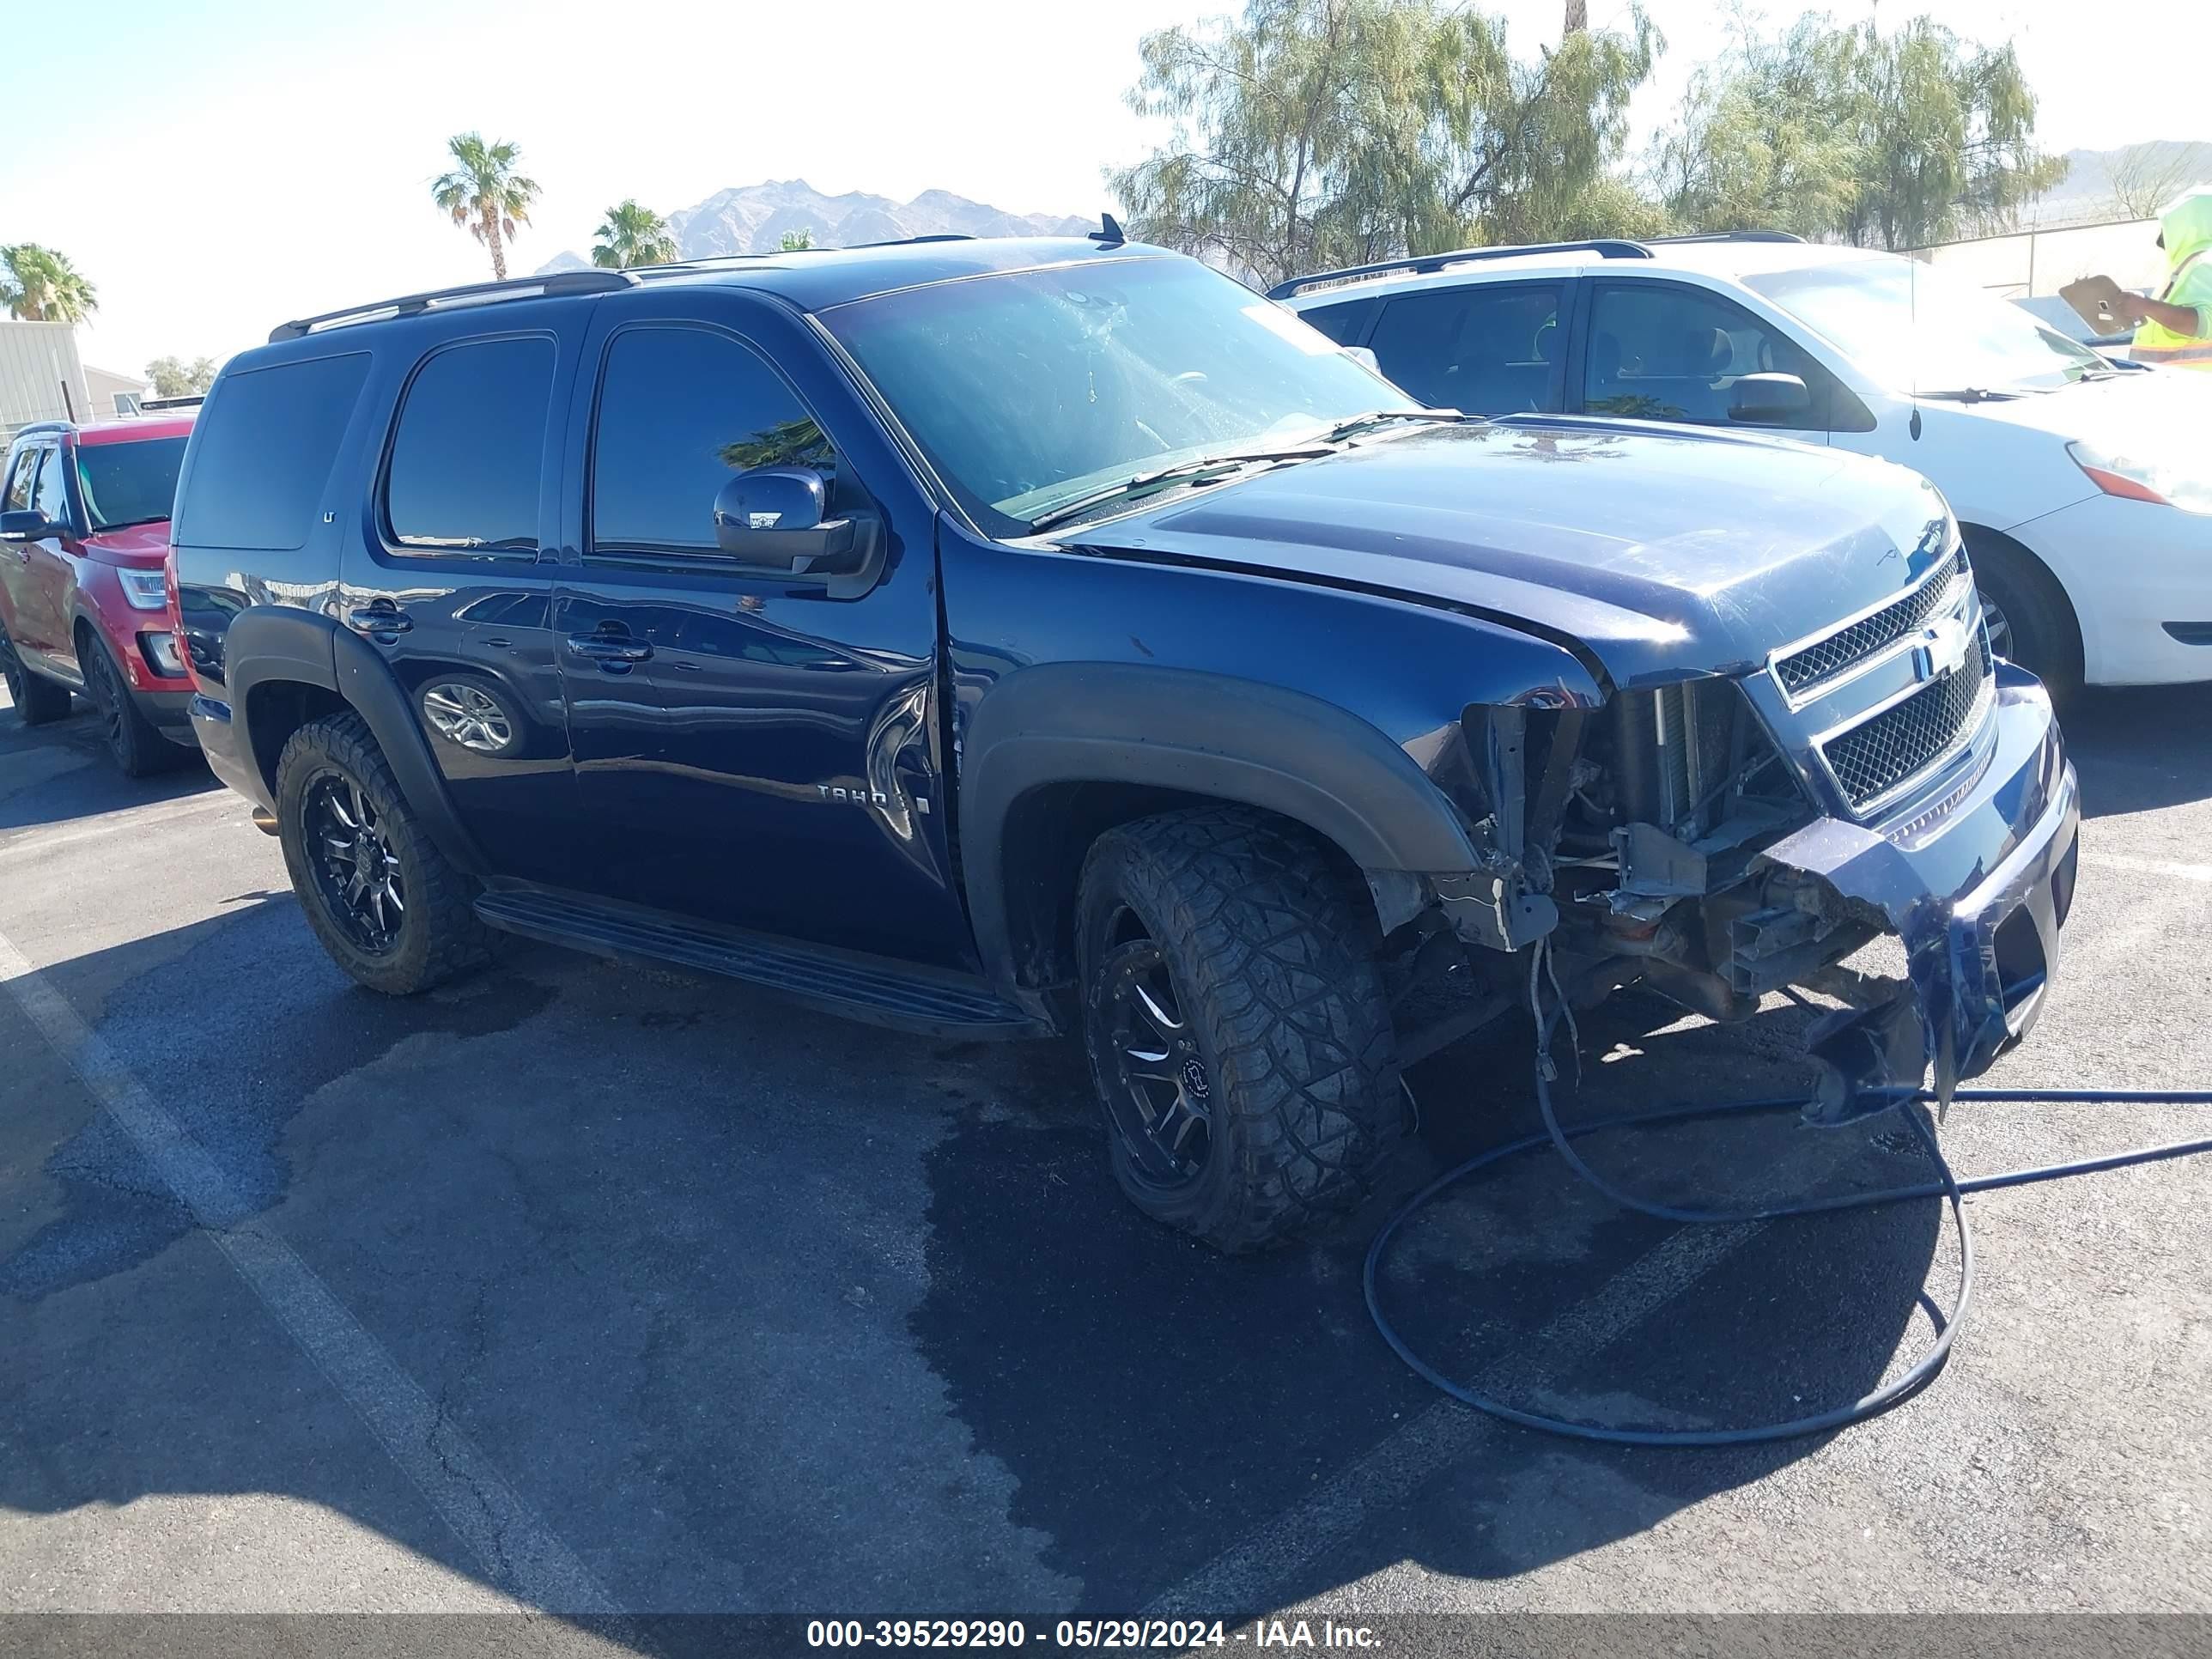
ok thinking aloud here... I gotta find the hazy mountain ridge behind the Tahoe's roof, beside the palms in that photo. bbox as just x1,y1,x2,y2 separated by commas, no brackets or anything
535,179,1097,276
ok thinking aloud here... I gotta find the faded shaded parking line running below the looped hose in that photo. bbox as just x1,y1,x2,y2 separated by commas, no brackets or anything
1144,1221,1765,1620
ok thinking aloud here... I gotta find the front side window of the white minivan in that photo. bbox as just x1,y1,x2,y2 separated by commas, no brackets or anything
1582,283,1834,431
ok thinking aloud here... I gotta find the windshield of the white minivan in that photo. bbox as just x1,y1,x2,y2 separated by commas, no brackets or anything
1743,258,2112,394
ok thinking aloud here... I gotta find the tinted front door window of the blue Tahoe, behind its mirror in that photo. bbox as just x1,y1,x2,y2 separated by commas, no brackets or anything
591,327,836,553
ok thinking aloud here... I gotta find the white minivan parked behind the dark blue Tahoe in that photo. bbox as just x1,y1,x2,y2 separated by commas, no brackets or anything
1272,232,2212,692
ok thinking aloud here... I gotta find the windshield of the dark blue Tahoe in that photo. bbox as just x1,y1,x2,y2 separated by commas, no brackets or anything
821,258,1407,535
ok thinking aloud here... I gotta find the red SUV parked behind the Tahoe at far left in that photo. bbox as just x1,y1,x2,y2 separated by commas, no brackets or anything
0,416,197,779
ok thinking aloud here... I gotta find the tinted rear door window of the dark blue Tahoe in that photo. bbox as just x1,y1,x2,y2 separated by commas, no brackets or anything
385,337,556,553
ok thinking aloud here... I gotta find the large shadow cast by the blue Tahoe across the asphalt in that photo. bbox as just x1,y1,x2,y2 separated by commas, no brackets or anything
0,898,1947,1617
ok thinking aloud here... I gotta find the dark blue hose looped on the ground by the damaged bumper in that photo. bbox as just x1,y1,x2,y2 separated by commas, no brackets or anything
1363,995,2212,1447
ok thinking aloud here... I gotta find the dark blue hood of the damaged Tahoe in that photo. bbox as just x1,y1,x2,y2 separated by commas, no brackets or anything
1055,428,1948,686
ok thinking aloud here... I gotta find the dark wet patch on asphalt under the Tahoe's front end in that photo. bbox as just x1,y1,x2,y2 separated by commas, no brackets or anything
914,998,1951,1617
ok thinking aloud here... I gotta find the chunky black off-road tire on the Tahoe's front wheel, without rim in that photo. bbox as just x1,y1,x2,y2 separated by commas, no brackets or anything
1078,807,1405,1255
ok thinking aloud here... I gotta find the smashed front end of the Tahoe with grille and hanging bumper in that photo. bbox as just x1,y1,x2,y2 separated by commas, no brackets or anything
1413,531,2079,1124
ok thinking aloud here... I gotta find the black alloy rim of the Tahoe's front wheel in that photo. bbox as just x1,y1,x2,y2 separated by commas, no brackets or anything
1102,907,1214,1190
